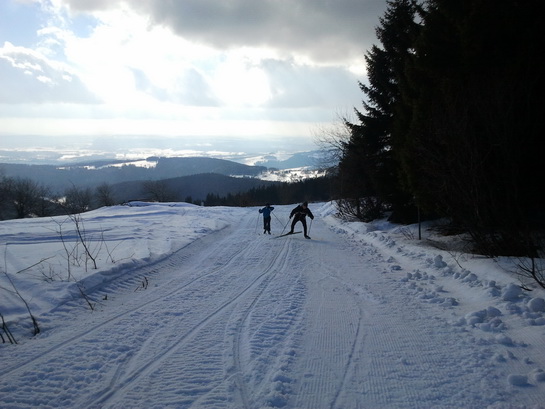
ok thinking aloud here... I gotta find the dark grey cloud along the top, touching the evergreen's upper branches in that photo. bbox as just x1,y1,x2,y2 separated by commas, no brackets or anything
123,0,386,64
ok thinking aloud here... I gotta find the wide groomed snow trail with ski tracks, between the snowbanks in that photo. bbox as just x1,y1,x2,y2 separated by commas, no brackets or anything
0,208,545,409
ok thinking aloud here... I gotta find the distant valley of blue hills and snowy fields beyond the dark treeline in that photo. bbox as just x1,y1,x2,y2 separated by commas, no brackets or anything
0,152,326,206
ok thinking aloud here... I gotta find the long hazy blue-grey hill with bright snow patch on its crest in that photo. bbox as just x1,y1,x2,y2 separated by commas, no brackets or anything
0,157,267,193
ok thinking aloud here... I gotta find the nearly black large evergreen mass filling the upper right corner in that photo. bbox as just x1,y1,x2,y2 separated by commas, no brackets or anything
396,0,544,252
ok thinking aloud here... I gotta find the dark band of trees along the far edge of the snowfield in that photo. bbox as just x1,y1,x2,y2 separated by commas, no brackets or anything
0,169,332,220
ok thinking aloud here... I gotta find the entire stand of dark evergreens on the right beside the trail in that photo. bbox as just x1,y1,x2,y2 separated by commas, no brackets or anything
333,0,545,257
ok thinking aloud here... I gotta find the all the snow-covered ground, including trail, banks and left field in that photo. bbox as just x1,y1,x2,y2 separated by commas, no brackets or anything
0,203,545,409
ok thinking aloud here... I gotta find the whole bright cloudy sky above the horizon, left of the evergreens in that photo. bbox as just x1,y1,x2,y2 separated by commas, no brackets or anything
0,0,386,161
